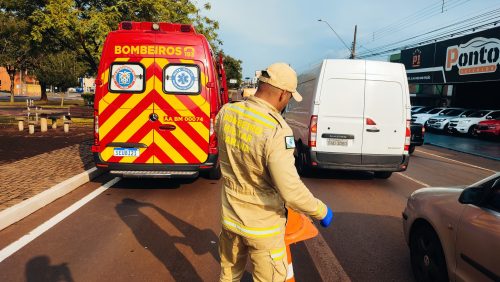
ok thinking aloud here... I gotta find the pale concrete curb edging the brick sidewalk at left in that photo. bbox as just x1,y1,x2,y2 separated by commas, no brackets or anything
0,167,102,230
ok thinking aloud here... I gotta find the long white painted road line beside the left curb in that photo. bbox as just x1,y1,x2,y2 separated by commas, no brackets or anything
0,177,121,262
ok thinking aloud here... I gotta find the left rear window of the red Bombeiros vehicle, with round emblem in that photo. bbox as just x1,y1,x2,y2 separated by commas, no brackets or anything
108,63,146,93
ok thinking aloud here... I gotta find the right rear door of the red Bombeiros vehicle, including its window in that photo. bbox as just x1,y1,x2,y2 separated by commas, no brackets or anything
154,44,210,164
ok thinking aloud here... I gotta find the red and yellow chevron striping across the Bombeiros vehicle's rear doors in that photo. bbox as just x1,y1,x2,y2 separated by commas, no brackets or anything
98,58,210,164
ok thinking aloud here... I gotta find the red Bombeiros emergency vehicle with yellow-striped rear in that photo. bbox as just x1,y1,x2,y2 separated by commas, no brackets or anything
92,22,228,179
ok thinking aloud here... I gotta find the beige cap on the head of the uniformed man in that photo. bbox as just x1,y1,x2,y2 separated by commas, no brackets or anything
259,63,302,102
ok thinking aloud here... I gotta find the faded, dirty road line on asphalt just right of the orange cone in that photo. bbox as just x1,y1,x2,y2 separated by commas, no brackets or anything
304,230,351,281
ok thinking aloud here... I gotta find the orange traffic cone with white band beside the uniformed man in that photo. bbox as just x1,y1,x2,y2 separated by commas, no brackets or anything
285,209,318,281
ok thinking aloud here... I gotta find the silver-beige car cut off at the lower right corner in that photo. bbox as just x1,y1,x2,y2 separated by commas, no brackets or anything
403,173,500,281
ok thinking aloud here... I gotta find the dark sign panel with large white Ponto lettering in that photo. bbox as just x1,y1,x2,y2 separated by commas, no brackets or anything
401,27,500,84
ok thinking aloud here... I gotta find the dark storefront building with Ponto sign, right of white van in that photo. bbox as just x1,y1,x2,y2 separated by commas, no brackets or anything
391,27,500,109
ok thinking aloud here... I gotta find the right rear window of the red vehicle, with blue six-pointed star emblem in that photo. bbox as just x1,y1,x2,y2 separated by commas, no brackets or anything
163,64,200,94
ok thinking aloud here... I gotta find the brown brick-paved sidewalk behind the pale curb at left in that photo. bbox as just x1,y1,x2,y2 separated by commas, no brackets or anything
0,141,94,212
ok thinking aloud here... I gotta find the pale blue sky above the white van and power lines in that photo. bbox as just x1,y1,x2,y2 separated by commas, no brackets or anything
200,0,500,78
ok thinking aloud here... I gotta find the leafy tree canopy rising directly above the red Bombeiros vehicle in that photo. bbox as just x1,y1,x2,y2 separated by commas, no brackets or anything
30,0,221,73
